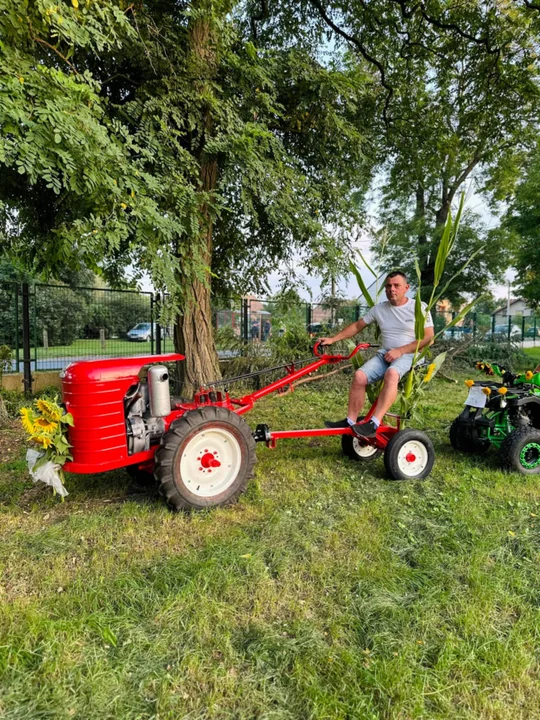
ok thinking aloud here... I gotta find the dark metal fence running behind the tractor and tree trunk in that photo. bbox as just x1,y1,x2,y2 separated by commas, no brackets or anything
0,282,540,389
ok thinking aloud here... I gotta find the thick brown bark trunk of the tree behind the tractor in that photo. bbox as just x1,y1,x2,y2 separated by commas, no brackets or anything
174,0,221,397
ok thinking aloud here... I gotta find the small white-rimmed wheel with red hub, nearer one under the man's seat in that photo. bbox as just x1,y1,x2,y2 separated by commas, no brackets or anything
384,429,435,480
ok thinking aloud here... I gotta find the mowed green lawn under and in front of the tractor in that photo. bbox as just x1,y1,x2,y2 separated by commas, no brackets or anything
0,378,540,720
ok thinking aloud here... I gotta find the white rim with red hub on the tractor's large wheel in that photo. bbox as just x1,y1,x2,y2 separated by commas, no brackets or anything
180,427,242,498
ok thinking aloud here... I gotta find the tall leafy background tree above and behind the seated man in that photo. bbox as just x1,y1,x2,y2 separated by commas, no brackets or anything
253,0,540,299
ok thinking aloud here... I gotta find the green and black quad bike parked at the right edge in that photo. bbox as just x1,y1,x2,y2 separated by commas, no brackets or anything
450,362,540,475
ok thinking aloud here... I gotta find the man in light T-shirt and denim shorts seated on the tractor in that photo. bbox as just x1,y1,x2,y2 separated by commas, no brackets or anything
321,270,434,437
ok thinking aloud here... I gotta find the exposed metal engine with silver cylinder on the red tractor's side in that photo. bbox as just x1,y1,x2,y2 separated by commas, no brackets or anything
124,365,171,455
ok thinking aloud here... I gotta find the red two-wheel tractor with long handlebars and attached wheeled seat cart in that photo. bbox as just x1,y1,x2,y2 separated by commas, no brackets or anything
62,343,434,509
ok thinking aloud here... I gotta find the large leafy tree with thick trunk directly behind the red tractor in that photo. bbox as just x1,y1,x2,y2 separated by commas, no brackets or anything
0,0,372,389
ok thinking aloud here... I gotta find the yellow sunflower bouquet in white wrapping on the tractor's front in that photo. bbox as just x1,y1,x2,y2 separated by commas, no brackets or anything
21,398,73,498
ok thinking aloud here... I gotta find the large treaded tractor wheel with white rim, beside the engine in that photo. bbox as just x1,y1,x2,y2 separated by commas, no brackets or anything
155,407,257,510
